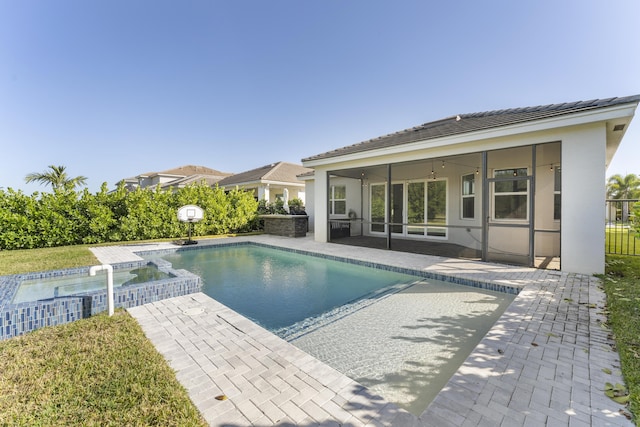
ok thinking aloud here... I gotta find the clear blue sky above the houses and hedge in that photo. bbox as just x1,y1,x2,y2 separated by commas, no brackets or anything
0,0,640,194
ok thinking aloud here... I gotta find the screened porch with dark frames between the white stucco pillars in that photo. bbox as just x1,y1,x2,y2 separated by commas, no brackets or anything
327,142,562,269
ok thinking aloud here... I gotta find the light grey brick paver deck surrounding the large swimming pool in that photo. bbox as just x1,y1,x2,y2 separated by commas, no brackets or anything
92,236,633,426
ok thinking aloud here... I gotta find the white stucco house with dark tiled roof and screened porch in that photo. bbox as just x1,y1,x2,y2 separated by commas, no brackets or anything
302,95,640,274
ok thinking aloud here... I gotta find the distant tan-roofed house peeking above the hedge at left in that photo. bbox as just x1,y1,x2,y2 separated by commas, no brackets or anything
119,165,232,190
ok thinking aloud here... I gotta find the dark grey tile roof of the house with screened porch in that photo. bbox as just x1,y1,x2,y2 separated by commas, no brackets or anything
302,95,640,162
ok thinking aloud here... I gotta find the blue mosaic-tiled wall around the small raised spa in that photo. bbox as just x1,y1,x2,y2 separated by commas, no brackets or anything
0,261,202,340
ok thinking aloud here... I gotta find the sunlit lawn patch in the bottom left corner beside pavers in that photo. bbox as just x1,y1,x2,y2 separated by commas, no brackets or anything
0,310,207,426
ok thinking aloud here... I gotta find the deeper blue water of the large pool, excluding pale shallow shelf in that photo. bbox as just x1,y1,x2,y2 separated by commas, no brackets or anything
162,246,419,331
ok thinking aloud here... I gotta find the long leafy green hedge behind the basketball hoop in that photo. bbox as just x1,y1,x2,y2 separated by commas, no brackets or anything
0,183,258,249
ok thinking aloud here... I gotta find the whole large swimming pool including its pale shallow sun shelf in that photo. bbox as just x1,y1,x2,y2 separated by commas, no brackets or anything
151,245,515,415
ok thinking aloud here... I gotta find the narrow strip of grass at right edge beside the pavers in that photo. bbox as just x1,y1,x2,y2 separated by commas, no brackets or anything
603,255,640,422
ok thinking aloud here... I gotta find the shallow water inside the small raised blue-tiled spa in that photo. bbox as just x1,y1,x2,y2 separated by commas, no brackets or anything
12,265,171,304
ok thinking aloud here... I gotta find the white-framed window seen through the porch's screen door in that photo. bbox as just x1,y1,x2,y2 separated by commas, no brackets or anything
493,168,529,220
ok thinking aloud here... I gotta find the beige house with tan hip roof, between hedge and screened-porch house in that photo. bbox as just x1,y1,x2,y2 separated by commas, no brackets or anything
218,162,312,203
